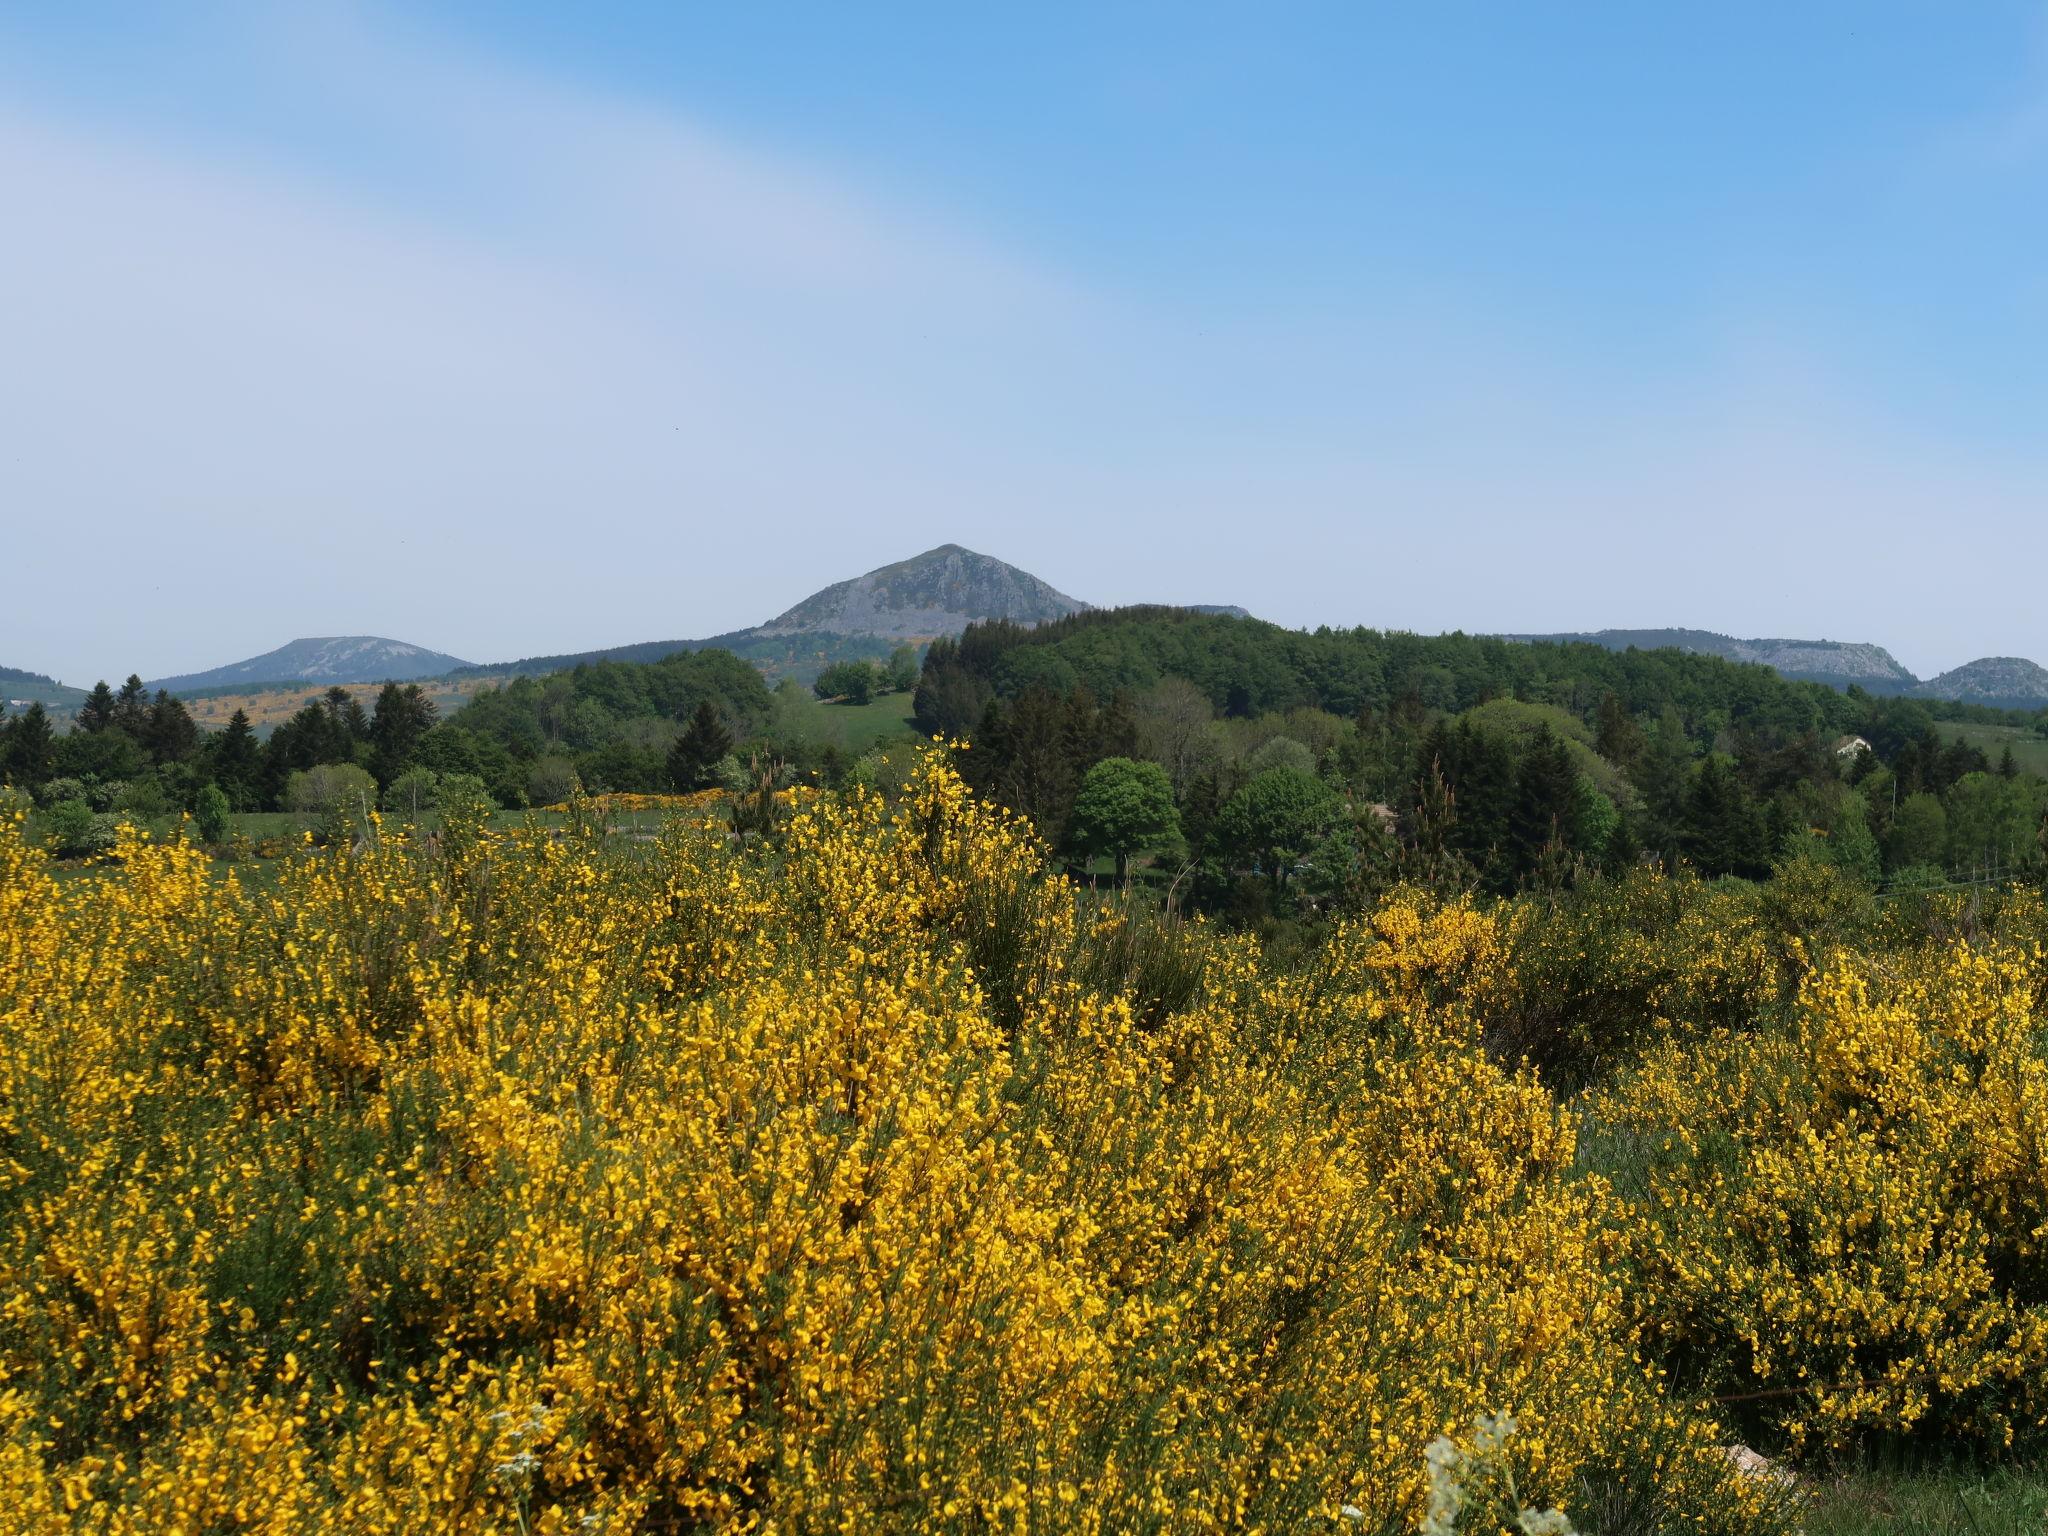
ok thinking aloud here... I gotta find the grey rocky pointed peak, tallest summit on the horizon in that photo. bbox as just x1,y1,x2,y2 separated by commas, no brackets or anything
754,545,1087,641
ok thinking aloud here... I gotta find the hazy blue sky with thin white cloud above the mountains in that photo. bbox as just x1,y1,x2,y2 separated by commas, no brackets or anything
0,0,2048,682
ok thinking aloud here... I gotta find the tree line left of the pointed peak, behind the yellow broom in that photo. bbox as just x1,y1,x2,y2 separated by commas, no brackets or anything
0,647,884,850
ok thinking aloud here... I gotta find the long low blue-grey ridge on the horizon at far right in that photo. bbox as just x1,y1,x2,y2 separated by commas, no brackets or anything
1501,629,2048,709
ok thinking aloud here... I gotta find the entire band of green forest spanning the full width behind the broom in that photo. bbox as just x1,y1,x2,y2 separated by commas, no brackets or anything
0,608,2048,915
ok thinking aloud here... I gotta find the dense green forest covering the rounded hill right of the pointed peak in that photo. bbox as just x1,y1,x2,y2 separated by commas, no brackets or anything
918,608,2048,905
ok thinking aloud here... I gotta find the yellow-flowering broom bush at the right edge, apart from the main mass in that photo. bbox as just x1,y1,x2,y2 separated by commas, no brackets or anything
1589,901,2048,1450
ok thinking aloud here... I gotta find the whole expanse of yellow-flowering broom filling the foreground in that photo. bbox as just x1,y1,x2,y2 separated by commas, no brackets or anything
0,752,2048,1536
